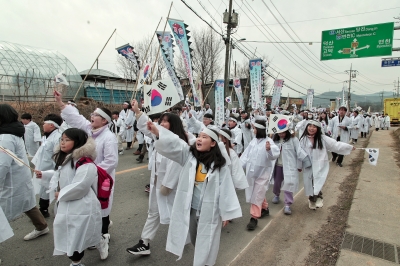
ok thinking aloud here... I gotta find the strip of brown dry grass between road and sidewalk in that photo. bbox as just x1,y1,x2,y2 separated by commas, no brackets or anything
306,134,371,266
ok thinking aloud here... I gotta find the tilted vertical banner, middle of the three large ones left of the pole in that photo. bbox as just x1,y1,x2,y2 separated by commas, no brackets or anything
156,31,185,101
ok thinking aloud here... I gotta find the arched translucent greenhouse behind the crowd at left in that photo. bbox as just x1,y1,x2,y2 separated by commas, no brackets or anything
0,41,83,101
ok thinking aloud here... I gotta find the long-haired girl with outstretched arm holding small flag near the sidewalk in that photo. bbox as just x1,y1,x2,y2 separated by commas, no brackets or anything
300,120,355,210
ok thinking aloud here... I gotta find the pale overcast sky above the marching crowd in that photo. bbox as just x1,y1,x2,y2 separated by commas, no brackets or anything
0,0,400,97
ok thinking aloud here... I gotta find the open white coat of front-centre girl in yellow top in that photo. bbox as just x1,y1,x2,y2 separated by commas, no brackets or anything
154,127,242,266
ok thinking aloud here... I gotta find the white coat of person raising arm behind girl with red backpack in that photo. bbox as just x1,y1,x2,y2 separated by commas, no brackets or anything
61,105,118,217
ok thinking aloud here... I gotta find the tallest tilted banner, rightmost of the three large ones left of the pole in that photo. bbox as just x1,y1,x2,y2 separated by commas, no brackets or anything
168,19,201,107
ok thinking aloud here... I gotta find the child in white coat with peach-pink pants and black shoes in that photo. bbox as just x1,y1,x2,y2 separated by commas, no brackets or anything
240,120,279,230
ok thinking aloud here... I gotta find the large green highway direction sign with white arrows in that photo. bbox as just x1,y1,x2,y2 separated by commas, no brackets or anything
321,22,394,61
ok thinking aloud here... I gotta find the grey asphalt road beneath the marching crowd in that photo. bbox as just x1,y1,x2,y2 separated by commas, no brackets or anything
0,143,303,266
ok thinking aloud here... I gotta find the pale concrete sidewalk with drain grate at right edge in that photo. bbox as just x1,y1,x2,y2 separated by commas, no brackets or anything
336,128,400,266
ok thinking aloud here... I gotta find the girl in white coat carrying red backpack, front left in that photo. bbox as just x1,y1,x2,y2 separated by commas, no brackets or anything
36,128,108,265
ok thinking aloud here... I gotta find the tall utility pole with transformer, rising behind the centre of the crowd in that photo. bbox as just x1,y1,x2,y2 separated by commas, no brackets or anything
223,0,238,96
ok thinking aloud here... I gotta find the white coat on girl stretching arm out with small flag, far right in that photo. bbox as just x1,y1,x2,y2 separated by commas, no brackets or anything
300,135,353,196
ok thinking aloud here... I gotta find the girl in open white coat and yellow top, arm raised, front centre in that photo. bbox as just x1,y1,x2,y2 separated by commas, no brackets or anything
147,122,242,266
